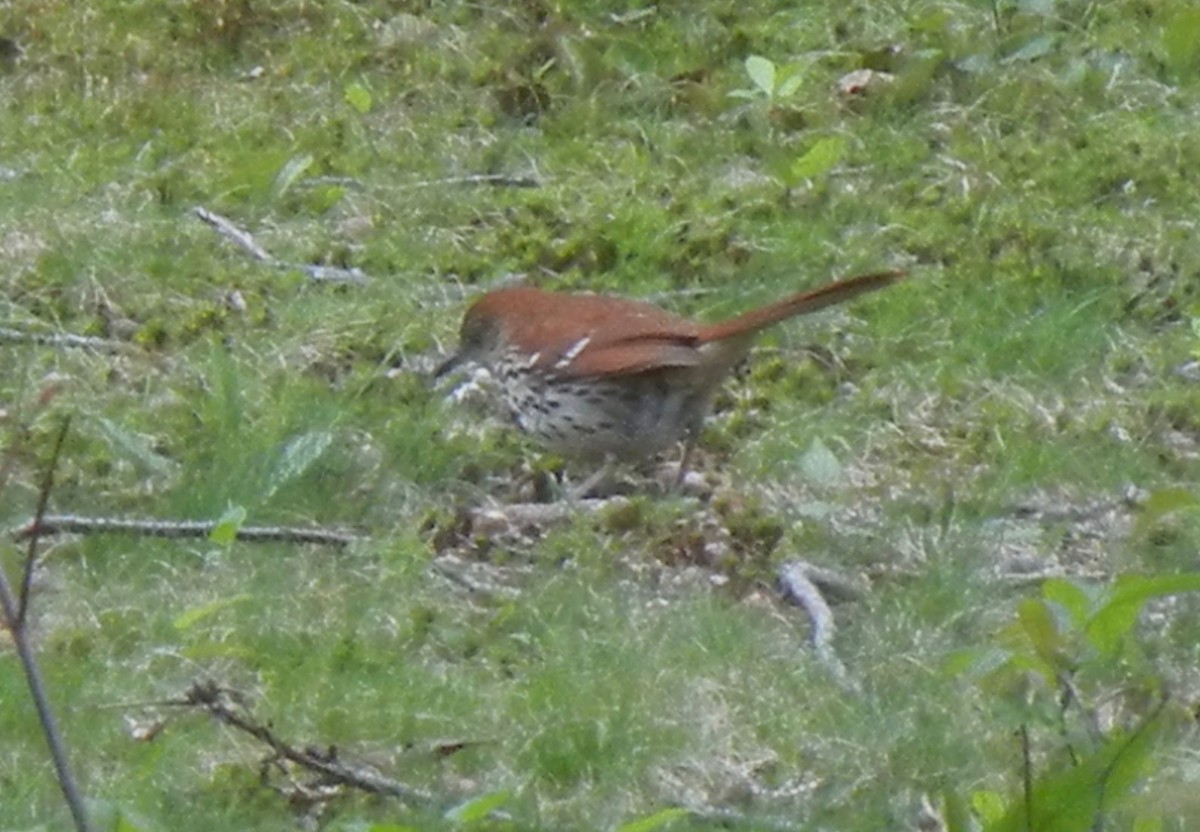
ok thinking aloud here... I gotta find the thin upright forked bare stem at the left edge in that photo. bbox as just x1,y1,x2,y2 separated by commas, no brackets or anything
0,419,94,832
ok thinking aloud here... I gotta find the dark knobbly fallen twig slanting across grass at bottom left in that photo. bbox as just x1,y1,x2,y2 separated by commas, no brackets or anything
179,681,434,806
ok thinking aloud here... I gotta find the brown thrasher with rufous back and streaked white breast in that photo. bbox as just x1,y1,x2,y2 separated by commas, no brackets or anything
436,271,904,463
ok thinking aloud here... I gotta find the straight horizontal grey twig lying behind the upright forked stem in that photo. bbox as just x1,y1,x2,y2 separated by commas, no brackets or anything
13,514,362,546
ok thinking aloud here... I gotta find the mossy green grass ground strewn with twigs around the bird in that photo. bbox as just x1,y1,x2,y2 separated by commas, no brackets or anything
0,0,1200,832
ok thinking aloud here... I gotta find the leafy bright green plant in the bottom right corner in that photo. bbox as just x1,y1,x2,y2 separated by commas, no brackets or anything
946,573,1200,832
